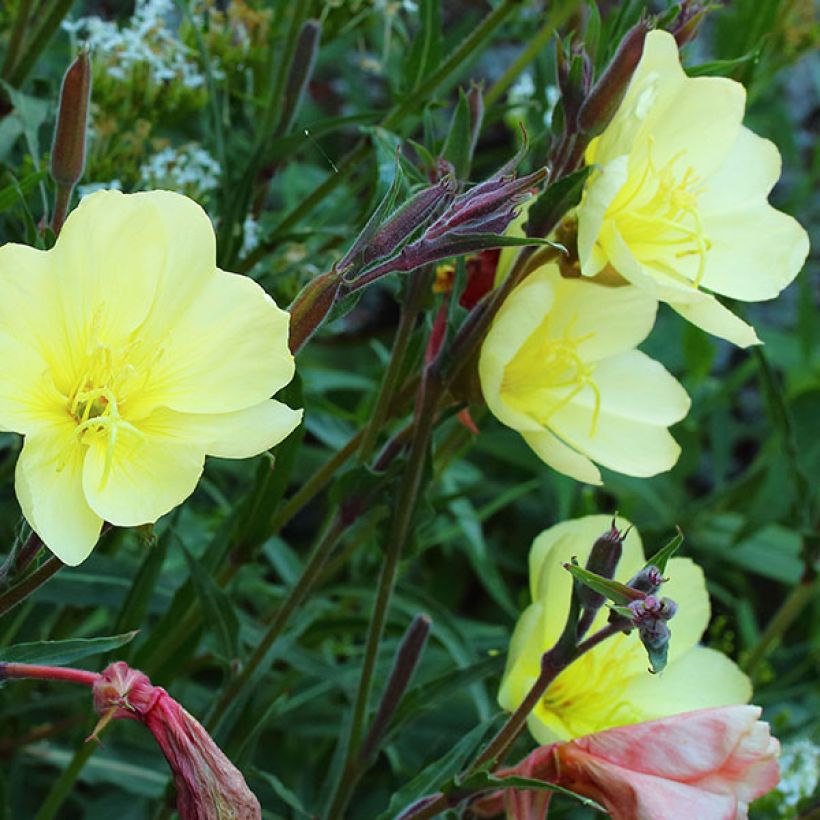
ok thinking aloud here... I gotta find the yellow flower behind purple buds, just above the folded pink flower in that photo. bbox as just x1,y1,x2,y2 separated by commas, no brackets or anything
498,515,752,744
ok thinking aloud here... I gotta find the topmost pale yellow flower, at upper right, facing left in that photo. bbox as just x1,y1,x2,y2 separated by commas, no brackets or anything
577,31,809,347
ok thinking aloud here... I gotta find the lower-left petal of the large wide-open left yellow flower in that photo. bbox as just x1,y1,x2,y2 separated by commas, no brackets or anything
14,422,102,566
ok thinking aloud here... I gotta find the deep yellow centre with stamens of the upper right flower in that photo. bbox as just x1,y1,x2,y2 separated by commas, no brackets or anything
609,138,712,287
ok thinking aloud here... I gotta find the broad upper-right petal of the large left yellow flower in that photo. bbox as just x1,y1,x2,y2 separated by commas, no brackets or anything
135,271,294,413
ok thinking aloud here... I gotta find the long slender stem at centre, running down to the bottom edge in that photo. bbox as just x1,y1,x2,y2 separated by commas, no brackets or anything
328,374,442,820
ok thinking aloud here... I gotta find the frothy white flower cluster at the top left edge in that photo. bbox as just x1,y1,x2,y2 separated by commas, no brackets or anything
63,0,205,88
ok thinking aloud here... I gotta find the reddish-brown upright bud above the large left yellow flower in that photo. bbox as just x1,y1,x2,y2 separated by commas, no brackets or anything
51,51,91,188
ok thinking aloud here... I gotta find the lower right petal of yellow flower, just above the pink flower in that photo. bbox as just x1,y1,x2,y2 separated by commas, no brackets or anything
624,648,752,720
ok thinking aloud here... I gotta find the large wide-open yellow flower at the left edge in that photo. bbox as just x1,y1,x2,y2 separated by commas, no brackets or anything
0,191,302,565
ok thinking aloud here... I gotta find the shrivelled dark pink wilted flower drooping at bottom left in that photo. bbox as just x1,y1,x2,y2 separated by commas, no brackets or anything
93,661,262,820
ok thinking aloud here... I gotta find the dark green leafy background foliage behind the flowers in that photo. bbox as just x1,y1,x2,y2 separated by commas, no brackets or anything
0,0,820,820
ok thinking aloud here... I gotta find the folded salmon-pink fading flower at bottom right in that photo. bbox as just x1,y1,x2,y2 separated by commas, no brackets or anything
473,706,780,820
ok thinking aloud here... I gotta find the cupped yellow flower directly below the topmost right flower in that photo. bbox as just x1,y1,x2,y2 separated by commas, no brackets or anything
479,264,690,484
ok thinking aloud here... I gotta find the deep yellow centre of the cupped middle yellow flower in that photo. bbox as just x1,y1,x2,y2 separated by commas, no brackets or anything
502,317,601,436
